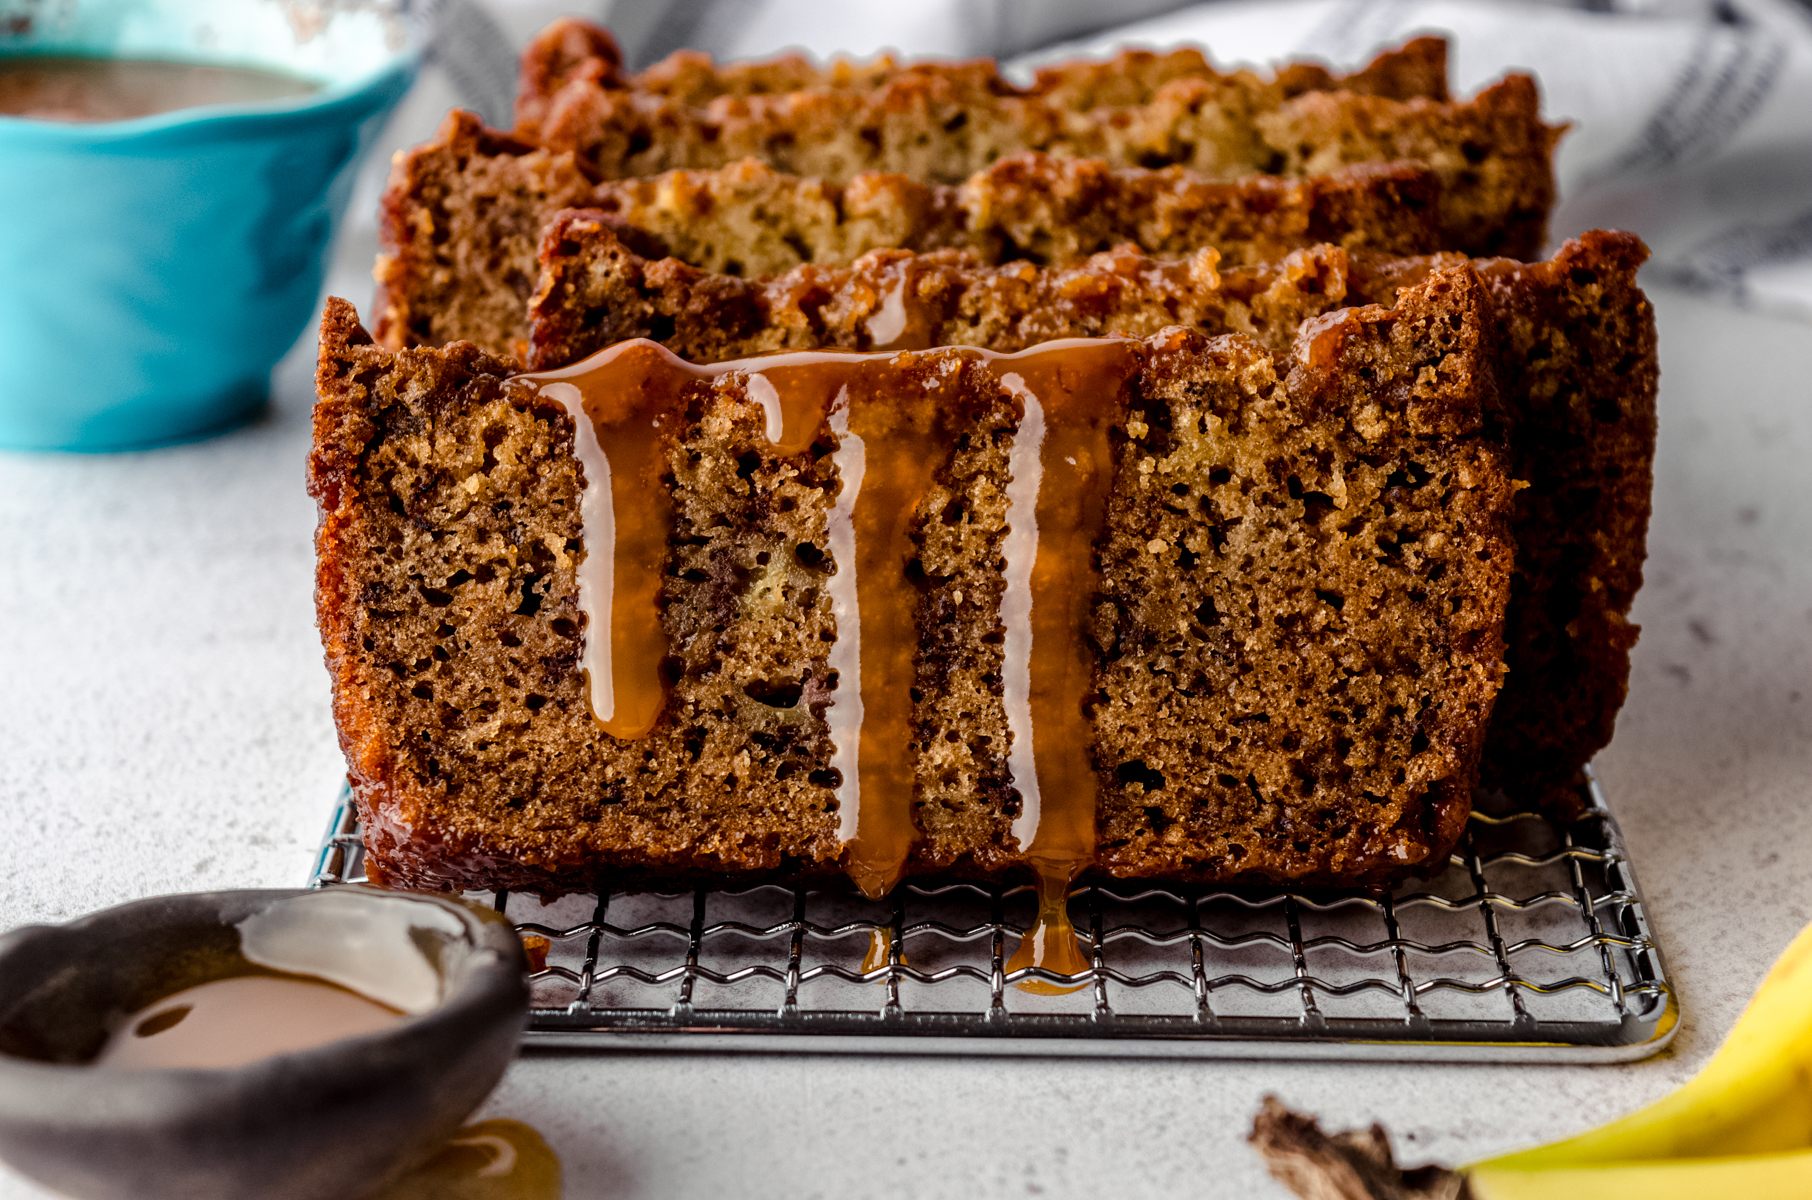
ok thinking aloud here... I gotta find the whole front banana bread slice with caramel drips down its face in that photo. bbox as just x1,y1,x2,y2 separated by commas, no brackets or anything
310,266,1511,894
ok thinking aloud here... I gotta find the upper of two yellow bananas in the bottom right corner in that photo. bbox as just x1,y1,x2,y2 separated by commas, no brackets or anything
1471,926,1812,1174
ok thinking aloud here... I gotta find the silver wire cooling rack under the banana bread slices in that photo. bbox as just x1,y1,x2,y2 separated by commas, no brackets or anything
313,778,1680,1062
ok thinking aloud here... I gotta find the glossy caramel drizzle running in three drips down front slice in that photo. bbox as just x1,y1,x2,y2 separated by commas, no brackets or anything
518,340,1136,942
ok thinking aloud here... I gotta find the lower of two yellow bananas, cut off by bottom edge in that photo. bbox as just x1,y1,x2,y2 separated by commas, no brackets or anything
1466,1149,1812,1200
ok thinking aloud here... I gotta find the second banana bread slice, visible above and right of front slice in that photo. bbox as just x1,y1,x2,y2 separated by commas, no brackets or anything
531,212,1658,814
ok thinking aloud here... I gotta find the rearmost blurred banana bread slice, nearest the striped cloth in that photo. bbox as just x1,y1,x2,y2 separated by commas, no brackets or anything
516,18,1560,257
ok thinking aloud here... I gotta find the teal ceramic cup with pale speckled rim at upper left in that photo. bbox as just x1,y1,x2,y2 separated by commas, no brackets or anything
0,0,420,450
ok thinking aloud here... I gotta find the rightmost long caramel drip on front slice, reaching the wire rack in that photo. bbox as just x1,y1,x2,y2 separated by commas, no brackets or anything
993,341,1138,992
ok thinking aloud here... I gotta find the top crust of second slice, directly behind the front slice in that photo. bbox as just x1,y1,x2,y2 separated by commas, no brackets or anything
529,210,1427,370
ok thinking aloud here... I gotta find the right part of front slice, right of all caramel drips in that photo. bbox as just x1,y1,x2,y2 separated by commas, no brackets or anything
1094,277,1511,886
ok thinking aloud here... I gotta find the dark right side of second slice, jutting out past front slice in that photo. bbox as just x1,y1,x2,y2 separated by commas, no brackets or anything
1480,232,1660,814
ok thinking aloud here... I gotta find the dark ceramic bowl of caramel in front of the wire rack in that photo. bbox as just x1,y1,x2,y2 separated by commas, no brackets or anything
0,886,527,1200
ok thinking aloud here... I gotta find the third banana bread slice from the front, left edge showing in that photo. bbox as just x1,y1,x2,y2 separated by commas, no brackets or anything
375,111,1444,357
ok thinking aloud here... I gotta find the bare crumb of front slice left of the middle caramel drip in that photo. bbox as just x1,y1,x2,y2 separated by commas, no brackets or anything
310,301,839,892
